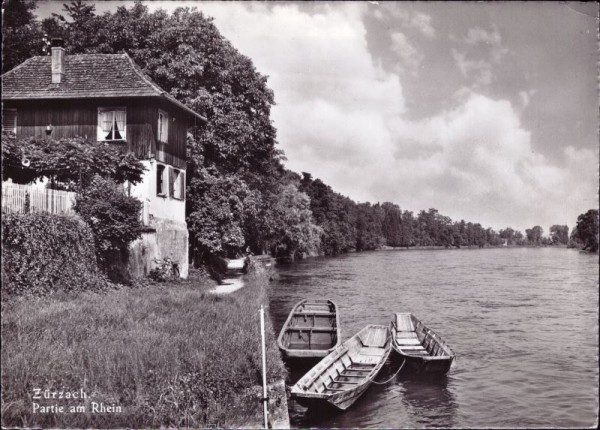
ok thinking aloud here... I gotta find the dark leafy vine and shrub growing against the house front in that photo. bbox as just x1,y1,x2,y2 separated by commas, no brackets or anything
2,133,144,282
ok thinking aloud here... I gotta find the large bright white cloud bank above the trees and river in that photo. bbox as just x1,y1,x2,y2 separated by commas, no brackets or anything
159,2,598,231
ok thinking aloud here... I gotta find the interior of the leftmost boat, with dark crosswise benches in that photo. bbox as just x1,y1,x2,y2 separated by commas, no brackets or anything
282,300,338,350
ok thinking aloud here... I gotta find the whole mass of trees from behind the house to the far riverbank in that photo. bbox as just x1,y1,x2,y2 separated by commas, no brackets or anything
3,0,597,268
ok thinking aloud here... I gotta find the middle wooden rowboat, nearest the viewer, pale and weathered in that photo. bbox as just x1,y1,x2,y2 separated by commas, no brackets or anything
291,325,392,410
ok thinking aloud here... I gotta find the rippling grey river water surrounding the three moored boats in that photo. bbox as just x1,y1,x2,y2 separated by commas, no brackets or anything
270,248,599,428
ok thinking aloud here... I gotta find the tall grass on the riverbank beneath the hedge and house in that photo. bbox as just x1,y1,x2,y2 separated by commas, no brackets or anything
2,264,285,428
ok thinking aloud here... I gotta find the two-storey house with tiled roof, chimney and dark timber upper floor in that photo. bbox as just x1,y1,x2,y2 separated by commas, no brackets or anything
2,39,206,277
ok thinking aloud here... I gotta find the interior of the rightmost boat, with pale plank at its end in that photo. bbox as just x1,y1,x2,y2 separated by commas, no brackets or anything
392,313,454,357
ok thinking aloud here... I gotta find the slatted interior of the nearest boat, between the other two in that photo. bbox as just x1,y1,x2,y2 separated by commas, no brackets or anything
299,326,390,394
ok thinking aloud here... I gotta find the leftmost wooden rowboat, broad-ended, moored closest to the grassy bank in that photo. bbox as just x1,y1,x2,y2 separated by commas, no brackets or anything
277,299,342,358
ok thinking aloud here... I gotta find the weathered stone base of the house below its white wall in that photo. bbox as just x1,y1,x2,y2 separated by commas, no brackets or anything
128,219,189,278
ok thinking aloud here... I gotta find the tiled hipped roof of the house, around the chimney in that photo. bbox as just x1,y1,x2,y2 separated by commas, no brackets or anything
2,54,205,120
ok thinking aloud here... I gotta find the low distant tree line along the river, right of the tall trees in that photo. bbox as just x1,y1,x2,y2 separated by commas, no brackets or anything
298,173,598,255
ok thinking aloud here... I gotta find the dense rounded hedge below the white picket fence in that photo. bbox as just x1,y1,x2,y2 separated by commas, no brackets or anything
2,213,108,300
